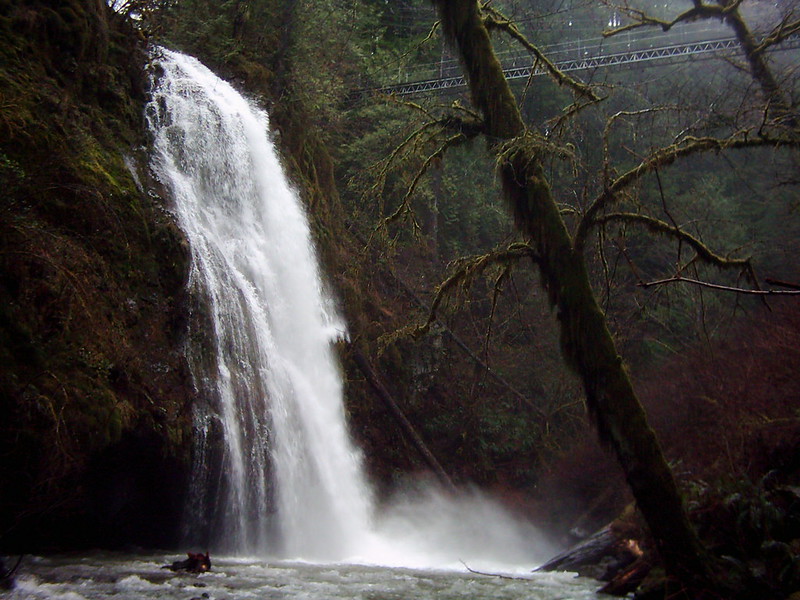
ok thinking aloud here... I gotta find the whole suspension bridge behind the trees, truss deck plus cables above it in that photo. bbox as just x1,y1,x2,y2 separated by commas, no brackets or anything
351,23,800,99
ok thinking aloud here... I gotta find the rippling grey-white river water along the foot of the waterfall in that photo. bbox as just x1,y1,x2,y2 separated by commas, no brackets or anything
9,553,598,600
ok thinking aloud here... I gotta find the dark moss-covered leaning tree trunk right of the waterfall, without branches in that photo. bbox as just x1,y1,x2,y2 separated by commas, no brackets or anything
433,0,713,587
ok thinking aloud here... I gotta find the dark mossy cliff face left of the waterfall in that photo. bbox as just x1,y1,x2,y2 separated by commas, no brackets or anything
0,0,194,551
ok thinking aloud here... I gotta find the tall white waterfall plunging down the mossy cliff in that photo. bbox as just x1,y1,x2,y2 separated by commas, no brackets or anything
146,49,372,559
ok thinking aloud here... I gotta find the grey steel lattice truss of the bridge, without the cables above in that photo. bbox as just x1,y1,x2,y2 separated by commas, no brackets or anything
352,34,800,98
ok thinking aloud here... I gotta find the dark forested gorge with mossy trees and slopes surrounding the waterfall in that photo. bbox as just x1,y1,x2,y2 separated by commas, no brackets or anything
0,0,800,598
